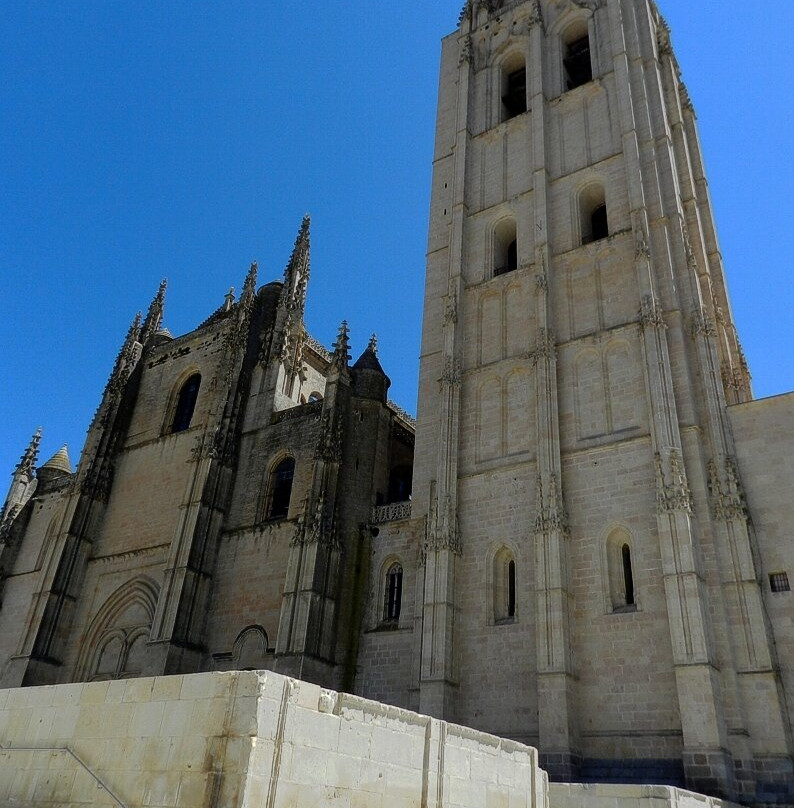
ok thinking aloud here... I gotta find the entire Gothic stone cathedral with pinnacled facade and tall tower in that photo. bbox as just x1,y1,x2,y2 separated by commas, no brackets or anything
0,0,794,806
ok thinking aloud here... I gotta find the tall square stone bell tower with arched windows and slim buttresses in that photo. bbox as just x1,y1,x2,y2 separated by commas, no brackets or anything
413,0,791,799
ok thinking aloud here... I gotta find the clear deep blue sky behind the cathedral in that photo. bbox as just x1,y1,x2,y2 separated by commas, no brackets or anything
0,0,794,476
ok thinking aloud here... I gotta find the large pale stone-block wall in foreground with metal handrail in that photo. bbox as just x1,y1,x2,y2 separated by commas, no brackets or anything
0,672,547,808
